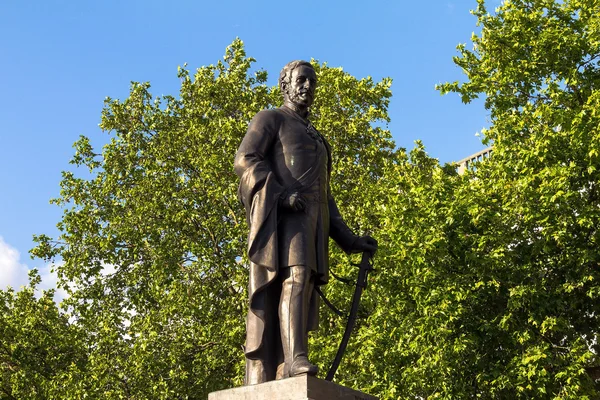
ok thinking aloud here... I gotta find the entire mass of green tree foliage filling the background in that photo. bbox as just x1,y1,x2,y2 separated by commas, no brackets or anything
0,0,600,399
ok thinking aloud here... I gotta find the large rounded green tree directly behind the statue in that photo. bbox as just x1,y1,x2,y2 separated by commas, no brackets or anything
24,40,394,399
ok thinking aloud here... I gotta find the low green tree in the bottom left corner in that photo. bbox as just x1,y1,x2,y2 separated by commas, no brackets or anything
0,270,87,399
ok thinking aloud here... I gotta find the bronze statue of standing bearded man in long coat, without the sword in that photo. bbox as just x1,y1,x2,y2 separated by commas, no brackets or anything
235,61,377,385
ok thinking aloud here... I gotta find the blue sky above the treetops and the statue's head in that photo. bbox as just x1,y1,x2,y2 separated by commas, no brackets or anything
0,0,492,288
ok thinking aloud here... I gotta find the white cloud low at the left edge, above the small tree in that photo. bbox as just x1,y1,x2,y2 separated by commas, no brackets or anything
0,236,67,303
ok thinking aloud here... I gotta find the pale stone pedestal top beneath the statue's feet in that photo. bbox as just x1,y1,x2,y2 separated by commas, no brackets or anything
208,375,377,400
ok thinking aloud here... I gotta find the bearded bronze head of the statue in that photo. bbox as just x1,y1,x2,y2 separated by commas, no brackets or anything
279,60,317,108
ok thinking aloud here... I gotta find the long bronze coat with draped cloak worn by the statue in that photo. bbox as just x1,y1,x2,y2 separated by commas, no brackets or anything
234,106,357,359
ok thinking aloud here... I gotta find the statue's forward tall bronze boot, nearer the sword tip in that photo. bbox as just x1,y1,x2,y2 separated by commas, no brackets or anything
279,265,318,377
